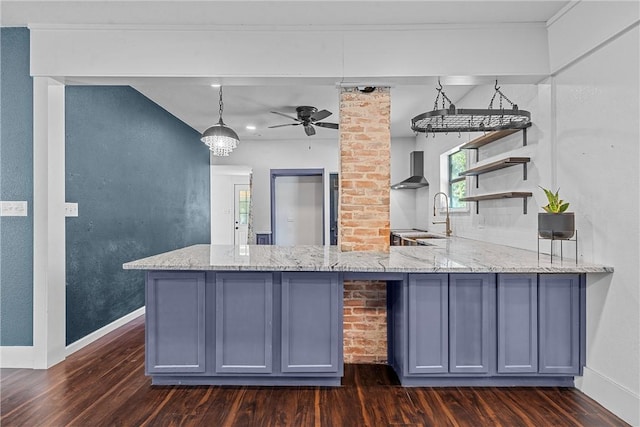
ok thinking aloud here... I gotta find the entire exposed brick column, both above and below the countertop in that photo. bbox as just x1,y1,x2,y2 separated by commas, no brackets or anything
338,88,391,363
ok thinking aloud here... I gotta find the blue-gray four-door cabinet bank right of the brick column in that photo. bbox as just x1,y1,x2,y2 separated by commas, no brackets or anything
387,273,586,386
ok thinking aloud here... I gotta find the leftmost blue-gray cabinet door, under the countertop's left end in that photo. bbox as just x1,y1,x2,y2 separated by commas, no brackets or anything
146,272,205,373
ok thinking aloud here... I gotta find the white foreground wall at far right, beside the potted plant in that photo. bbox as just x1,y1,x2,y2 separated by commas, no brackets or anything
552,26,640,425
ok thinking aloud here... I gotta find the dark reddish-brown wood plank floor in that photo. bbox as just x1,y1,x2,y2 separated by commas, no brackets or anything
0,317,626,427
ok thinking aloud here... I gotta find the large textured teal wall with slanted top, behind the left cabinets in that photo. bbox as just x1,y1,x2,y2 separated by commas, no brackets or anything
65,86,210,344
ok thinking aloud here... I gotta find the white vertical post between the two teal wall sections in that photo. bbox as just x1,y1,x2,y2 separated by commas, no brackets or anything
33,77,66,369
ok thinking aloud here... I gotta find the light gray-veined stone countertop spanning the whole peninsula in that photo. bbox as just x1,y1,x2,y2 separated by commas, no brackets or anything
123,237,613,273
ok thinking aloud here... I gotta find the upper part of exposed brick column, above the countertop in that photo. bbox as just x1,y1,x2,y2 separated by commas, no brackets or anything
338,88,391,252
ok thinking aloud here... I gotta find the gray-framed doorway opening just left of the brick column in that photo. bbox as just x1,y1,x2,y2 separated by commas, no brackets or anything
271,169,324,246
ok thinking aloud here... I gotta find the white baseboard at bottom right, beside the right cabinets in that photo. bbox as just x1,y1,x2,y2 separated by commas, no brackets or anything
576,367,640,426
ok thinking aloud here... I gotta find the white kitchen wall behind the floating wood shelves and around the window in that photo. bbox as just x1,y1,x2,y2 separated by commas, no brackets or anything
416,85,548,246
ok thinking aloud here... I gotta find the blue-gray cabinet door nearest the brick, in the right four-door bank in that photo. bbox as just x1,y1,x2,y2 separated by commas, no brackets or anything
408,274,449,374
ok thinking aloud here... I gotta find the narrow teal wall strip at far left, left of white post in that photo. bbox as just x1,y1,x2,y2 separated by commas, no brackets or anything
0,28,33,346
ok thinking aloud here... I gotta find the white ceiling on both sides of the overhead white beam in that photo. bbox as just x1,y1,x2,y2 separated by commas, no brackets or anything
0,0,570,140
